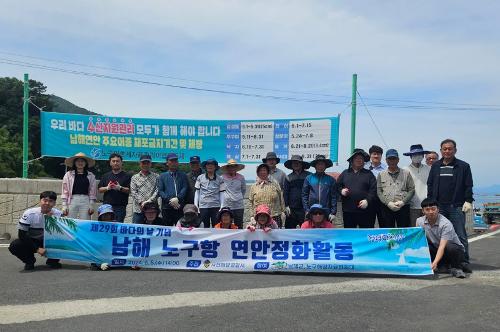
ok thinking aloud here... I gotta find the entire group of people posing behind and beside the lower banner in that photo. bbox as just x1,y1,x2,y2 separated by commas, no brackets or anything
11,139,473,277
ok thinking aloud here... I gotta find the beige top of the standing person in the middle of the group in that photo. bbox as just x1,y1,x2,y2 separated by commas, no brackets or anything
248,180,285,217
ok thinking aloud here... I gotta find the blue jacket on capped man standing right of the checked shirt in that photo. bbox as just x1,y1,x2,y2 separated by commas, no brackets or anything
158,171,189,209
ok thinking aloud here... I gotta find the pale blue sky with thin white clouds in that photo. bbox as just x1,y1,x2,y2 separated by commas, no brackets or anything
0,0,500,186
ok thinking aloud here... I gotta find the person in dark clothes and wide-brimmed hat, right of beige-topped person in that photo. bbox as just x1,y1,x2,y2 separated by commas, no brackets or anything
283,155,311,228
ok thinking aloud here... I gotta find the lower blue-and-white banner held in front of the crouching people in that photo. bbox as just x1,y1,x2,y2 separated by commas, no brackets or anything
44,217,432,275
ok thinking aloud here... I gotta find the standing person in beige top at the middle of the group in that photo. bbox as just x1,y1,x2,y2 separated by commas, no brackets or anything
248,164,285,228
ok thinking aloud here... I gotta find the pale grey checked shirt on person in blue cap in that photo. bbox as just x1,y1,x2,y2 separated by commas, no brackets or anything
130,172,160,213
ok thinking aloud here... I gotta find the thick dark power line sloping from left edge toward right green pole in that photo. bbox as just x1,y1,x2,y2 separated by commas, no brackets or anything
0,58,352,105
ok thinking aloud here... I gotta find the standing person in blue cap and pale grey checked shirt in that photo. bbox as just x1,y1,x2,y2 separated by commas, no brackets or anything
130,154,160,224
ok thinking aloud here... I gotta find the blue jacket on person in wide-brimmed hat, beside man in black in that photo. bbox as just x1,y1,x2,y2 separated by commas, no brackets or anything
302,173,337,214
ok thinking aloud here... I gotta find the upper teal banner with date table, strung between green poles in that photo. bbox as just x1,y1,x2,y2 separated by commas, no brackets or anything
41,112,339,163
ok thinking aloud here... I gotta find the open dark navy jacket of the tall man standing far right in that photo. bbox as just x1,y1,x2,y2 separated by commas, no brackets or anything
427,158,474,207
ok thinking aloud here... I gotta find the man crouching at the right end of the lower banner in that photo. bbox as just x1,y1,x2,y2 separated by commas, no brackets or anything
417,198,465,278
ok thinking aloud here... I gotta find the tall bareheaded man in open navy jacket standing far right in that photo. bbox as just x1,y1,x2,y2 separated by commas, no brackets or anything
427,138,474,273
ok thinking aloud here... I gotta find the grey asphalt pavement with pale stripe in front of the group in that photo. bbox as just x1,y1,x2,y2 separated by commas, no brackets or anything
0,233,500,331
